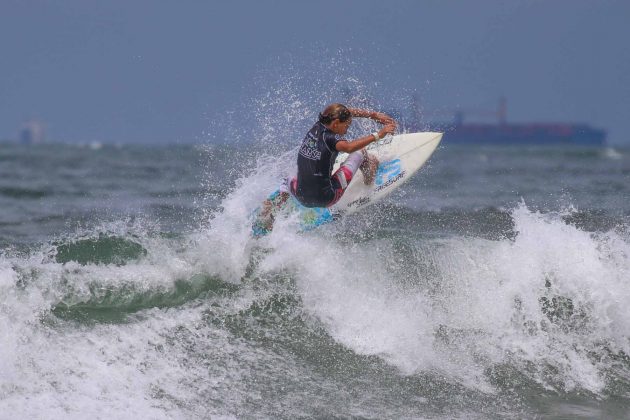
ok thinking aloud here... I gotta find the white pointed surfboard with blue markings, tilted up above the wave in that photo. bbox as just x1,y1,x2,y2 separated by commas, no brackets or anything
252,132,443,236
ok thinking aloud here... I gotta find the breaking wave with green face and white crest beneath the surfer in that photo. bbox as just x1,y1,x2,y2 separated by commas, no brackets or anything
3,192,630,396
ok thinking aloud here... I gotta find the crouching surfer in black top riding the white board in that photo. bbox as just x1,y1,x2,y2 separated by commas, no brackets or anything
259,103,396,230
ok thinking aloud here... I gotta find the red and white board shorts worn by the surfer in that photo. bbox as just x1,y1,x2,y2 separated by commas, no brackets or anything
285,151,364,207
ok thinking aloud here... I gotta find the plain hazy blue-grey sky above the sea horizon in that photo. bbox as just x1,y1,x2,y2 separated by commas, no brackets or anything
0,0,630,144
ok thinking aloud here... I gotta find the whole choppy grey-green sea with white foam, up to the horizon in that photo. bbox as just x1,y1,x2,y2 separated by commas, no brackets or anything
0,139,630,419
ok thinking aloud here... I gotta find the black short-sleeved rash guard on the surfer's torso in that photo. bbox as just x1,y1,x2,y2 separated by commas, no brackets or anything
295,122,341,207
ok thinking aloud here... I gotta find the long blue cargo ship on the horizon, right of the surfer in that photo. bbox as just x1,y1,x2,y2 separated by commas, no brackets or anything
408,98,607,146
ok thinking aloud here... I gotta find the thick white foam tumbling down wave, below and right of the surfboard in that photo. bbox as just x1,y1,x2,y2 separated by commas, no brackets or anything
256,205,630,394
